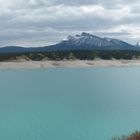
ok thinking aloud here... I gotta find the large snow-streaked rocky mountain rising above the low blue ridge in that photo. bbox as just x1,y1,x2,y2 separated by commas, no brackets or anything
44,32,140,50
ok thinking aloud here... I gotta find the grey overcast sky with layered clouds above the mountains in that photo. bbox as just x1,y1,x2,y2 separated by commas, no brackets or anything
0,0,140,47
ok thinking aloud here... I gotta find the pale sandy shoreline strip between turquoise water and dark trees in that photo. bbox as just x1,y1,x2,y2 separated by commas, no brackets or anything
0,60,140,70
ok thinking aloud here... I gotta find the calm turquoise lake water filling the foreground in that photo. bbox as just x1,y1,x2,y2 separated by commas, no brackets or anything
0,67,140,140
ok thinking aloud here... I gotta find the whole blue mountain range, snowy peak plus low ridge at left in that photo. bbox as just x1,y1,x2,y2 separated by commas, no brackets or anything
0,32,140,53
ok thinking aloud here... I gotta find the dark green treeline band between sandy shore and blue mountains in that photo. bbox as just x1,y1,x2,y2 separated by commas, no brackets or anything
0,50,140,61
